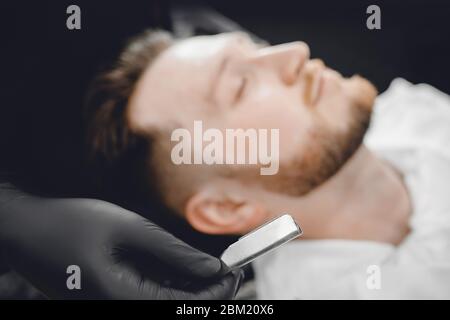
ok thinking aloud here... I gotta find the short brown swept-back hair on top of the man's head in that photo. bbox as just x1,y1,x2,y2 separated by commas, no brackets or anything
85,30,173,200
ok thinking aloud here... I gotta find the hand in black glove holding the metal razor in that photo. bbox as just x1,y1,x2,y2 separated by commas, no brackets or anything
0,184,242,299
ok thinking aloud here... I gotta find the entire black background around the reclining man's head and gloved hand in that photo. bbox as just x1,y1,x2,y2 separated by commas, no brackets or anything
0,0,450,253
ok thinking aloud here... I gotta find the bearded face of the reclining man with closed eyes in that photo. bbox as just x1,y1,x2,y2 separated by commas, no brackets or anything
128,33,376,232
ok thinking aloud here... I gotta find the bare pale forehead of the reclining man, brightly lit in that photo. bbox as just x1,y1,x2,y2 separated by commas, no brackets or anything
128,33,253,129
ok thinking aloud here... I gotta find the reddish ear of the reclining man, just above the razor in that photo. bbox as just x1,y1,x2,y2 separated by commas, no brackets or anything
185,188,267,234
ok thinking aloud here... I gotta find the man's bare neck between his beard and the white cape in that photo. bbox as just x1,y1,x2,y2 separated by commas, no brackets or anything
268,146,411,244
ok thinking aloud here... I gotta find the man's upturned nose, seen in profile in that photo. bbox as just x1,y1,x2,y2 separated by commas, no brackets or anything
253,41,310,85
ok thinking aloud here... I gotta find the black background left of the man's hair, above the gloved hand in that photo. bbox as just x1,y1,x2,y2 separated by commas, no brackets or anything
0,0,170,195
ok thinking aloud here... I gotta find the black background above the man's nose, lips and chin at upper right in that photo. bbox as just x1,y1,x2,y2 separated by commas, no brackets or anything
200,0,450,93
